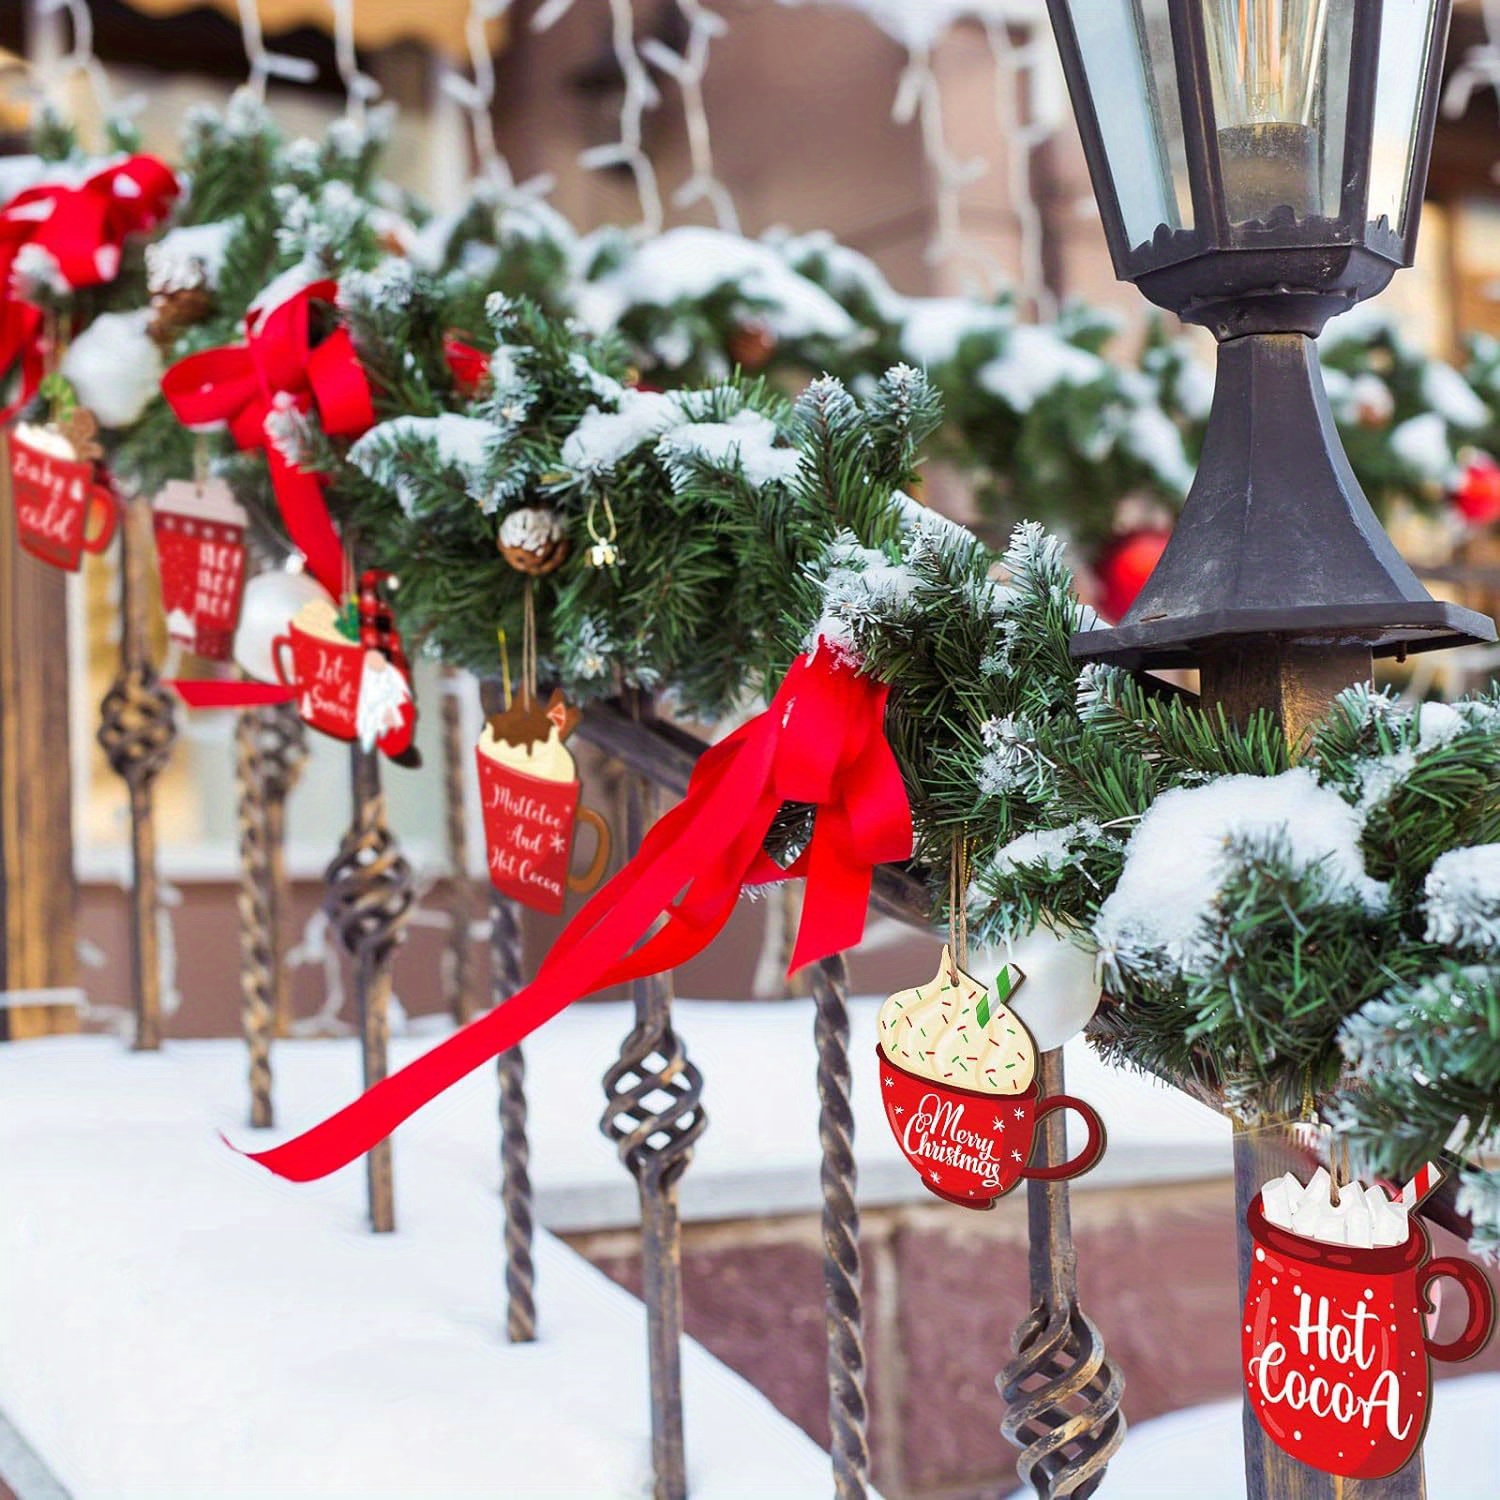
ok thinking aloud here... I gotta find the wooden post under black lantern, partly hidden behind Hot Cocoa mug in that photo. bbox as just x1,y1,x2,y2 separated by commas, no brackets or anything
1202,641,1427,1500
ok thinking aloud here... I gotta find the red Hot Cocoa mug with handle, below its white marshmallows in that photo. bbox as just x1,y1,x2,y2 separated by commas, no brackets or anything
1241,1194,1496,1479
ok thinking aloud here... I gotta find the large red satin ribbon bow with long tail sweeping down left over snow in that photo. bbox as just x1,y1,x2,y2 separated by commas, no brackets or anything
251,650,912,1182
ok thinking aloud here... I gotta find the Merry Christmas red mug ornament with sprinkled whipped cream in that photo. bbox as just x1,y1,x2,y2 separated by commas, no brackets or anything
876,948,1104,1209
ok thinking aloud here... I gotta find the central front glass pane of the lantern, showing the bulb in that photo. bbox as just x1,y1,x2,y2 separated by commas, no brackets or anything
1203,0,1356,224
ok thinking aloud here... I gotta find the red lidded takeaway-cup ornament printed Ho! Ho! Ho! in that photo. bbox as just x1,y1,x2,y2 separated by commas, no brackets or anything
152,480,246,662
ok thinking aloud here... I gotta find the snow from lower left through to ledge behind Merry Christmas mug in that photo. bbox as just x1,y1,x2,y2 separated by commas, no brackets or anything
0,999,1229,1500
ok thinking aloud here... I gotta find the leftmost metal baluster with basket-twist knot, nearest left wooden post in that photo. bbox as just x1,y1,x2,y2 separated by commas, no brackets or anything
98,495,177,1052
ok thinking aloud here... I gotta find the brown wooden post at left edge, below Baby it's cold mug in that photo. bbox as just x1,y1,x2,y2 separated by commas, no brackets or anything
0,438,81,1041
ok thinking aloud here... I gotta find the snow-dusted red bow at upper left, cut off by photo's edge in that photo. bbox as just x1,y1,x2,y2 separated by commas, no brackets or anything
0,156,177,416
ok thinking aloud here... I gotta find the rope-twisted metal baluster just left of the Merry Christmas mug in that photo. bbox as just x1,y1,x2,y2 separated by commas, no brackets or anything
813,954,870,1500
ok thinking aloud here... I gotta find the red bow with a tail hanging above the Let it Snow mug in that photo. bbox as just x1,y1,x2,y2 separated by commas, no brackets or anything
162,281,375,599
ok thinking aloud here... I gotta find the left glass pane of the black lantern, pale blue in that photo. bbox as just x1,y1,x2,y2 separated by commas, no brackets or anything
1070,0,1193,248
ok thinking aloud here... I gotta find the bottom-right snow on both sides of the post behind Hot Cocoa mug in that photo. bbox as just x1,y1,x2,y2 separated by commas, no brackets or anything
1011,1376,1500,1500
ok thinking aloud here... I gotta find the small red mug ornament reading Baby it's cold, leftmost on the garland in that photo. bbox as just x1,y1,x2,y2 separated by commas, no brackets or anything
11,423,119,573
